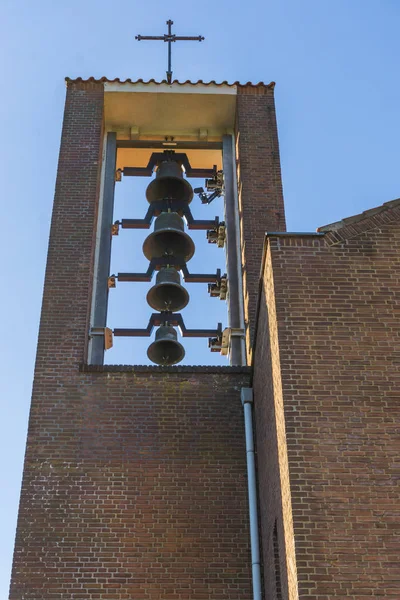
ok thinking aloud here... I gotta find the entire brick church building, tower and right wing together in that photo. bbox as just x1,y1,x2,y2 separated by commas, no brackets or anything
10,79,400,600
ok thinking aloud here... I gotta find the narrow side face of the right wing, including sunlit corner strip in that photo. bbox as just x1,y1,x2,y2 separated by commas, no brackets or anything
253,243,297,600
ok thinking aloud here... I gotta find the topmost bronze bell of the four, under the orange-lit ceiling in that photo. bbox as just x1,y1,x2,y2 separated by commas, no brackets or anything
146,161,193,204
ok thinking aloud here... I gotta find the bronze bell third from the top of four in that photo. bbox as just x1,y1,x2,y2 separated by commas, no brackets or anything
146,267,189,312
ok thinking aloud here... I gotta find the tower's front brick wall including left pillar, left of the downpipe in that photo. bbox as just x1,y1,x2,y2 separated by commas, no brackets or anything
10,83,251,600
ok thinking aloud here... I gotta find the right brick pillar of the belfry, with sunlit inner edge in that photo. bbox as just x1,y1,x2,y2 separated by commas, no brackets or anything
236,84,286,362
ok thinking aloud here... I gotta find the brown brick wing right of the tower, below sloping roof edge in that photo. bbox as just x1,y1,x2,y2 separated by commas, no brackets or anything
254,218,400,600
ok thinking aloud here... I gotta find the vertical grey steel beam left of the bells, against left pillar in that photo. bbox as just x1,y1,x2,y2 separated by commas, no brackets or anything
88,132,117,365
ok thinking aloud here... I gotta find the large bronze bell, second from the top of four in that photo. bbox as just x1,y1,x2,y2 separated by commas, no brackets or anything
143,212,194,262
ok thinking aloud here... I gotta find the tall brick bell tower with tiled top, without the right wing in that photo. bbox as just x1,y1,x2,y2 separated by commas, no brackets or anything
10,79,285,600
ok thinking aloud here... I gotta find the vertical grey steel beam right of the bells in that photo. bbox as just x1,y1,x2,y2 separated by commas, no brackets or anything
222,135,245,365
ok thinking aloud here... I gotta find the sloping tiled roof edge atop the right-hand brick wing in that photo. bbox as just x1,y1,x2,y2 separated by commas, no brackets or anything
317,198,400,244
